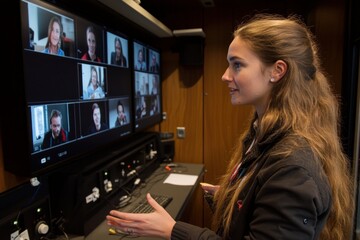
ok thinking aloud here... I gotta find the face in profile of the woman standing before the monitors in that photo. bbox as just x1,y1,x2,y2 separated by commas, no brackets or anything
221,37,272,113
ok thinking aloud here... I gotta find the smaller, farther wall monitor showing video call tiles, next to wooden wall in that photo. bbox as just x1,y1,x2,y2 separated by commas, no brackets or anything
133,40,162,132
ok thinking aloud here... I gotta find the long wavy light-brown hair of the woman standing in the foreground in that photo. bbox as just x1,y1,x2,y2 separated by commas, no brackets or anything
213,14,354,240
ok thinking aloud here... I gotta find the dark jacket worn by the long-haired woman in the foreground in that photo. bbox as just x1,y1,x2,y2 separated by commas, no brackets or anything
171,126,331,240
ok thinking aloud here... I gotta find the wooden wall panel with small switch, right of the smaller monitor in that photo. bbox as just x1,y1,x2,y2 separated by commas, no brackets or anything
160,48,203,226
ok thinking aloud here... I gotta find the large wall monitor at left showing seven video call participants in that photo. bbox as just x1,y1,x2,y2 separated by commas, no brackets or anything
2,0,134,176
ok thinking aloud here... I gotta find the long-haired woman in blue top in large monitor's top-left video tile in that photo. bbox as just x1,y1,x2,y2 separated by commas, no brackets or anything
43,16,65,56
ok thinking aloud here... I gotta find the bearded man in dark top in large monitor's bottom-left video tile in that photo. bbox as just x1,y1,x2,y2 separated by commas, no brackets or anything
41,109,68,149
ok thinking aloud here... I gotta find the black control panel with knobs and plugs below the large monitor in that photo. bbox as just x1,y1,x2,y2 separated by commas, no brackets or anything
50,134,160,236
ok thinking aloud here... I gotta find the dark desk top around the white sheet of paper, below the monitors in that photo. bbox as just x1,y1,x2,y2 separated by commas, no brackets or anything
70,163,204,240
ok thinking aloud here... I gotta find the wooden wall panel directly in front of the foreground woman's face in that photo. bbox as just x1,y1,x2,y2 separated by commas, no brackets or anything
204,6,255,227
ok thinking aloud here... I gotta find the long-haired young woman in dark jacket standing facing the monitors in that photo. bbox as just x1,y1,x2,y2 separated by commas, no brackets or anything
107,15,354,240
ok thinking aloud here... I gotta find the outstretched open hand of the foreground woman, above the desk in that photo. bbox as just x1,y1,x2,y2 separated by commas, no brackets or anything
106,193,176,239
